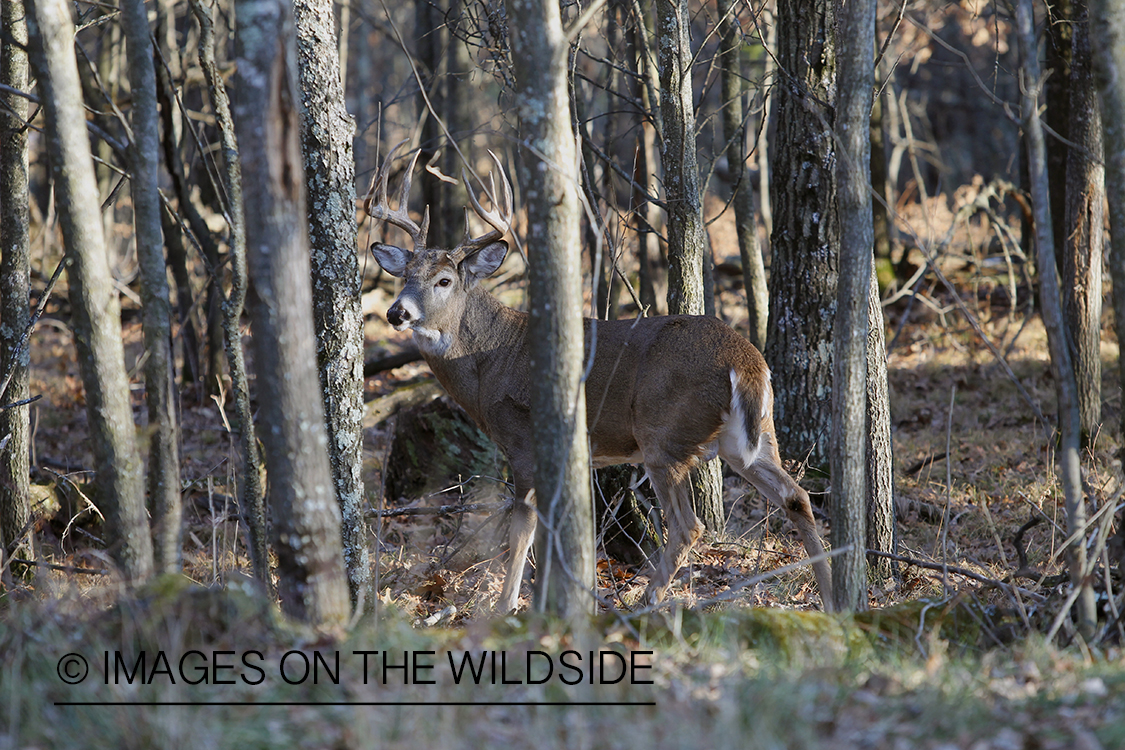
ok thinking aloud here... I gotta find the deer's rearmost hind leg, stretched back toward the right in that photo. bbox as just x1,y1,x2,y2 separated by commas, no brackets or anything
720,432,834,612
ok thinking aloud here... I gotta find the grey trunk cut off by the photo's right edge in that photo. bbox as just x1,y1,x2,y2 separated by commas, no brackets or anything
1090,0,1125,461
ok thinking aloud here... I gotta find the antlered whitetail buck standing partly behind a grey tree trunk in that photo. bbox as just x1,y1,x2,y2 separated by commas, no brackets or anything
365,142,833,613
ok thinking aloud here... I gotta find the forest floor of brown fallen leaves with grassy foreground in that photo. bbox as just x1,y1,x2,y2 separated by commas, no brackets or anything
0,202,1125,750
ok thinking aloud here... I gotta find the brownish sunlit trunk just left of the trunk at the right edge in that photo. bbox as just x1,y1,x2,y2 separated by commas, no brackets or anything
1061,0,1106,445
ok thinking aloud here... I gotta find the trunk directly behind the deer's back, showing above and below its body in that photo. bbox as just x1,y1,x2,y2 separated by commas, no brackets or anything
656,0,726,532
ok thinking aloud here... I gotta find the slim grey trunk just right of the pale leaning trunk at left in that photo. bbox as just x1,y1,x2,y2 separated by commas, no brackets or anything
122,0,183,572
